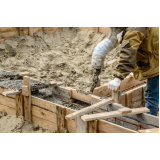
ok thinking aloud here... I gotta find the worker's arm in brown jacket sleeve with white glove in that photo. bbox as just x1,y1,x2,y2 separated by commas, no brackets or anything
109,27,147,90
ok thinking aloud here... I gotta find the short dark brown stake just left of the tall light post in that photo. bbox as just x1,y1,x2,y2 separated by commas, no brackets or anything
16,94,24,118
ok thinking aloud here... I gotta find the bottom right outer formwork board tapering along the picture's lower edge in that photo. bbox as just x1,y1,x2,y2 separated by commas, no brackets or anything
98,120,137,133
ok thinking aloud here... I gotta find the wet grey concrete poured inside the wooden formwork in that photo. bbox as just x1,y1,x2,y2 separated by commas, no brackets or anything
0,79,90,110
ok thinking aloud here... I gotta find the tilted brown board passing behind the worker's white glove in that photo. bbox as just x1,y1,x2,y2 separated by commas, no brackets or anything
93,75,146,97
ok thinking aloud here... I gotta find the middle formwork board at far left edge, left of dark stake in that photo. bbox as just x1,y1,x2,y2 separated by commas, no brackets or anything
0,95,16,109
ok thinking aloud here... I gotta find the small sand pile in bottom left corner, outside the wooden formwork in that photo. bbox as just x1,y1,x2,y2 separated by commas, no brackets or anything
0,110,51,133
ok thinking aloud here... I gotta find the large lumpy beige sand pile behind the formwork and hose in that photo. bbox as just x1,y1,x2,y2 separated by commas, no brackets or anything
0,28,116,91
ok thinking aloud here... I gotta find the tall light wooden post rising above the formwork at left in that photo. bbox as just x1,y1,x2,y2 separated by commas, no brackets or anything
22,76,32,121
